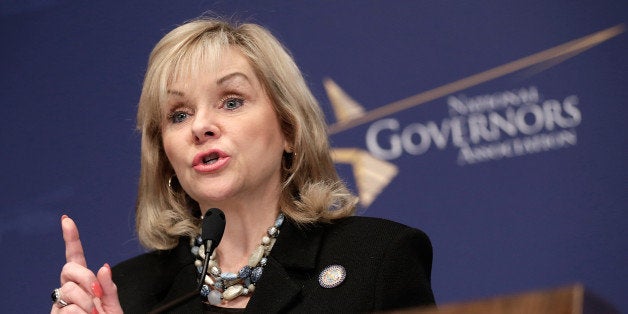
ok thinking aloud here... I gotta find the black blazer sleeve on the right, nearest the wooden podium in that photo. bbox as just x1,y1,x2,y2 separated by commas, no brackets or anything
374,227,435,309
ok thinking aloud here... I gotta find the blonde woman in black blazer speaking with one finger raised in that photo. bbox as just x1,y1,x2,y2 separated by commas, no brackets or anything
52,19,434,313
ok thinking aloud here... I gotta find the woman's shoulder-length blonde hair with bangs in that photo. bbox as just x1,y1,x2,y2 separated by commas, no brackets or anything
136,18,357,249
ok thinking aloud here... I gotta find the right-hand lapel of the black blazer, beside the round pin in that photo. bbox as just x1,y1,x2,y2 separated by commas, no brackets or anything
246,219,323,313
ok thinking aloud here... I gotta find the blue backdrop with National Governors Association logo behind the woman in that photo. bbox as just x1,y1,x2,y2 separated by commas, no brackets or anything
0,0,628,313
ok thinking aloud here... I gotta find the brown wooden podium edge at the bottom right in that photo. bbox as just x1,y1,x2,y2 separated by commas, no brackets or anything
390,284,619,314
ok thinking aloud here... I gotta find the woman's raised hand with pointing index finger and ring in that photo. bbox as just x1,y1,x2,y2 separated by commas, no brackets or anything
50,215,122,313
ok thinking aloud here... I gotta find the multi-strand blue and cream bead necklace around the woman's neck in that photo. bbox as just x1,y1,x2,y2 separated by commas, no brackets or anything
190,213,284,305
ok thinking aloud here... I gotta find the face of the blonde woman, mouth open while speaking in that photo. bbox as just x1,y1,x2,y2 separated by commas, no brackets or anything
162,48,288,210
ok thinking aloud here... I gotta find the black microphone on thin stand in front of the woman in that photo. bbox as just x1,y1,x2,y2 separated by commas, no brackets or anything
150,208,226,313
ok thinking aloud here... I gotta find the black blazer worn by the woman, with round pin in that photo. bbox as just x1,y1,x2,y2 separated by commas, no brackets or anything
113,217,434,313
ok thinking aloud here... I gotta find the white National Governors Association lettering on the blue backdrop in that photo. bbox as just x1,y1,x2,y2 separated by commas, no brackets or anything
366,86,582,166
